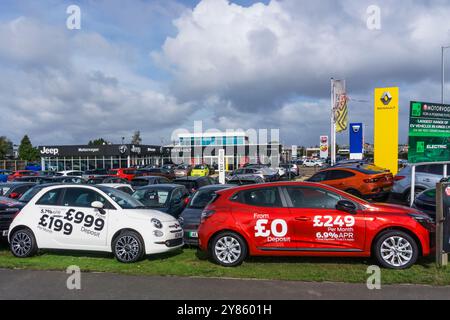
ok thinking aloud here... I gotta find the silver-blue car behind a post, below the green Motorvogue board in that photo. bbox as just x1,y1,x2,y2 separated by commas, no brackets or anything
392,164,450,204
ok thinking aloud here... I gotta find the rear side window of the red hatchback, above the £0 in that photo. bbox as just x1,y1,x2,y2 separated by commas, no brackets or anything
233,187,283,208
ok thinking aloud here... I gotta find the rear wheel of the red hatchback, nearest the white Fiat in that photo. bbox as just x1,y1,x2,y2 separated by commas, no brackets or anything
210,232,248,267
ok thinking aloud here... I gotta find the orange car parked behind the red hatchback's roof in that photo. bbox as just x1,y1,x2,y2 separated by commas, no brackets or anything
307,167,394,200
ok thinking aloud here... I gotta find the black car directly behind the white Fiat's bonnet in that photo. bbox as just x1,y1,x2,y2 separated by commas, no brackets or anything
133,184,189,218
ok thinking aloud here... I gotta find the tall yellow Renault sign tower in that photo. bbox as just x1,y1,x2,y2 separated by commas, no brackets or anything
374,88,399,175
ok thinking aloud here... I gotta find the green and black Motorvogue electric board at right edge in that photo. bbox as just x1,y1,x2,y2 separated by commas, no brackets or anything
408,101,450,163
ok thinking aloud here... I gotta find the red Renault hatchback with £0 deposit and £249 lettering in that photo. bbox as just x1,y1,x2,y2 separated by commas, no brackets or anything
199,182,434,269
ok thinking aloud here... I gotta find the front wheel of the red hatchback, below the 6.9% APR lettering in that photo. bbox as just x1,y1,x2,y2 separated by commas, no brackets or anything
374,230,419,270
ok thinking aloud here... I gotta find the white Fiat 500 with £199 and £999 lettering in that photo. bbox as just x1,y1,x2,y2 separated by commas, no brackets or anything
8,185,183,263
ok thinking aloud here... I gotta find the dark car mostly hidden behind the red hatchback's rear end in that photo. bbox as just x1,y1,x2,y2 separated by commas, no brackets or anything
179,184,235,246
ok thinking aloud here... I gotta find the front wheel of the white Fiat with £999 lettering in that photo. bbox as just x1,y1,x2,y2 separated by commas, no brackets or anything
112,231,145,263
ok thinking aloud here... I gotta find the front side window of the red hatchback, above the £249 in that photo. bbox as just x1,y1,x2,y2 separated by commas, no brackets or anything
286,187,342,209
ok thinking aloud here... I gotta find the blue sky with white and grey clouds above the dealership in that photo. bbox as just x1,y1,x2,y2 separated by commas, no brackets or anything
0,0,450,146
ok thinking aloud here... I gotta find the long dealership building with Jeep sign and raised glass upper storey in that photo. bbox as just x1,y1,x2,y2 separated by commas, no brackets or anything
39,131,282,171
